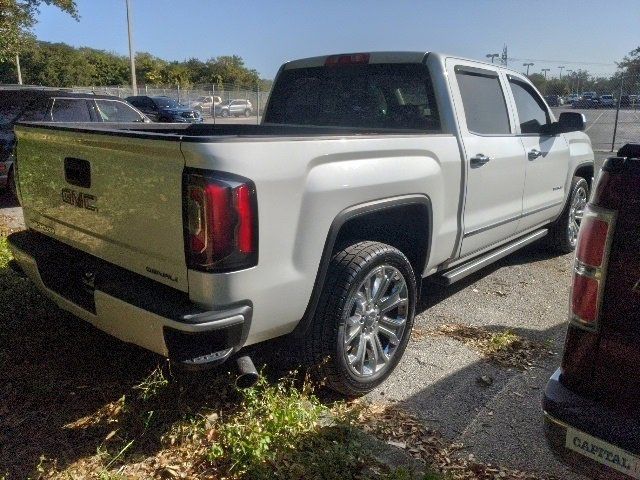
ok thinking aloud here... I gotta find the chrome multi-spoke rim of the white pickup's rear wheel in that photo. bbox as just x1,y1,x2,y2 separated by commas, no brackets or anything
342,265,409,377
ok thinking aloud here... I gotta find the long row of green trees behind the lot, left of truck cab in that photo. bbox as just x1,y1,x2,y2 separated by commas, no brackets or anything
0,41,270,90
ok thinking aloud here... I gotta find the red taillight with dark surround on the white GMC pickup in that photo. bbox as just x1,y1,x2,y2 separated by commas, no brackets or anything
183,172,258,272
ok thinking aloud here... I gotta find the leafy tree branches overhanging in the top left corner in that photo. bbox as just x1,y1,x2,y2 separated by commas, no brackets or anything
0,0,80,62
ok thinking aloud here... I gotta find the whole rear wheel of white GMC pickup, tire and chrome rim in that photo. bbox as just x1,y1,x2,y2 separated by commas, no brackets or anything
305,242,417,396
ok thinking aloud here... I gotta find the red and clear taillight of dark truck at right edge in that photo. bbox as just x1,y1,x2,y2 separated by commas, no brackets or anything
569,204,615,331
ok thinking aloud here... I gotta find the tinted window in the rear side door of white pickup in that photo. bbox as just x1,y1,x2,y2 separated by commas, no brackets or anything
456,68,511,135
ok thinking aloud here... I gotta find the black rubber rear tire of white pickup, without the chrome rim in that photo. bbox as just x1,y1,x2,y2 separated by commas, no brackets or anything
304,241,417,397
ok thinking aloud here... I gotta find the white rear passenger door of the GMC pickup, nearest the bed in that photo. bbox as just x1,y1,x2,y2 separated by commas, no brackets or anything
447,59,525,256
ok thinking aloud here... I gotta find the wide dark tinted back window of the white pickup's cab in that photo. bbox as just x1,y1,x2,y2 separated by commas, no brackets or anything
265,64,440,132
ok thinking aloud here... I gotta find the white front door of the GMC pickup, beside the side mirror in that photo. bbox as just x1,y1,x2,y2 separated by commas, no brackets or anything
507,74,569,231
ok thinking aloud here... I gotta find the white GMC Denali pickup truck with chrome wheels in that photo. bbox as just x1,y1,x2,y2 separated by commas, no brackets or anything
9,52,593,395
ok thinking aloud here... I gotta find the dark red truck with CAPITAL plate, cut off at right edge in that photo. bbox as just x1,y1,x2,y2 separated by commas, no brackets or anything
543,144,640,479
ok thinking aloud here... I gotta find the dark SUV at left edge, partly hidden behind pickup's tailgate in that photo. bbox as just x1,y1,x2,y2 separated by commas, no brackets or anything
0,87,149,198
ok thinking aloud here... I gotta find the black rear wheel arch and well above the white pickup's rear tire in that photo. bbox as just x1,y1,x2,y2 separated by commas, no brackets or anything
293,194,433,335
